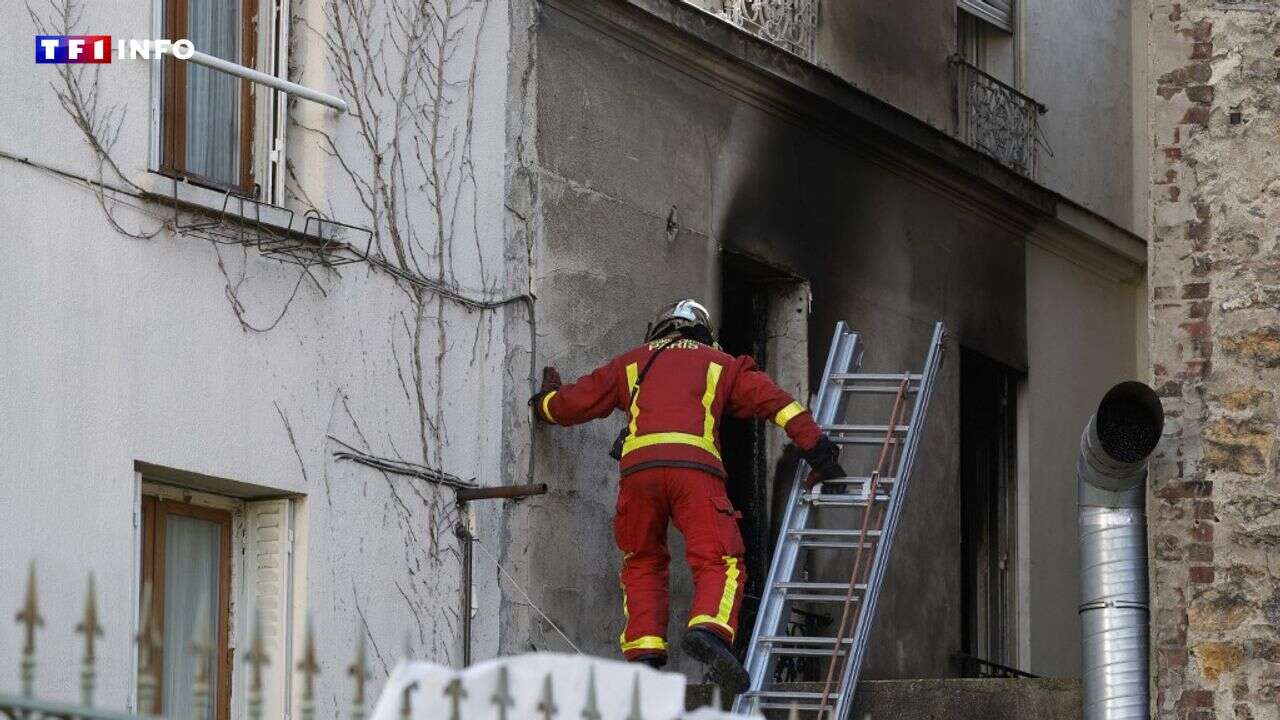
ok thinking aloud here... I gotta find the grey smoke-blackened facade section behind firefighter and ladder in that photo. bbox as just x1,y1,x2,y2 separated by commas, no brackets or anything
517,0,1146,678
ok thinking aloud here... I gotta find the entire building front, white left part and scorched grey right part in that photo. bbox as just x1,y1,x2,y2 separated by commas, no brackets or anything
0,0,1155,716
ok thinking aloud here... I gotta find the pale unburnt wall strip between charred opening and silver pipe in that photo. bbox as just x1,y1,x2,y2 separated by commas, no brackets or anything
1018,243,1146,676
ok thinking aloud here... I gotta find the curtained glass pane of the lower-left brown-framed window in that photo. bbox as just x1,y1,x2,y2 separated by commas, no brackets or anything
161,515,223,720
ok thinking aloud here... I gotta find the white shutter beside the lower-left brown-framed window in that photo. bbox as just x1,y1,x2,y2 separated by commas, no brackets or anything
237,500,293,717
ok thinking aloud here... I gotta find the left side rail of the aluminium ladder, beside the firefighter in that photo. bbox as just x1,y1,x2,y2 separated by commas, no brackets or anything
735,320,860,712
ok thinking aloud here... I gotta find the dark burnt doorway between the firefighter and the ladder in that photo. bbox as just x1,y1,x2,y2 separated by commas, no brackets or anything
718,254,808,650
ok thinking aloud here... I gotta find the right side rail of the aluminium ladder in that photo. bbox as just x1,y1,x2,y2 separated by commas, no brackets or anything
832,323,946,720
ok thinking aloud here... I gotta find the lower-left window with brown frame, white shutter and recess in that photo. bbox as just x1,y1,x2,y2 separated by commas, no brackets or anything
138,476,301,720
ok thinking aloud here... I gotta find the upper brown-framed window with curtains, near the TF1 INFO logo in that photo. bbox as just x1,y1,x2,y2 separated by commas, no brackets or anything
160,0,257,195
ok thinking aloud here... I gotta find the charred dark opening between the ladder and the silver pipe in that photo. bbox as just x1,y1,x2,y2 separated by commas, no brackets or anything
960,348,1019,666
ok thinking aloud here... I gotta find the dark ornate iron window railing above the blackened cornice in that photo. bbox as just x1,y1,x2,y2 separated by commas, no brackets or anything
950,55,1053,179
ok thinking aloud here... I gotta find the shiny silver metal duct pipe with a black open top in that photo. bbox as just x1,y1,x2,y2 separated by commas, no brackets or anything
1075,382,1165,720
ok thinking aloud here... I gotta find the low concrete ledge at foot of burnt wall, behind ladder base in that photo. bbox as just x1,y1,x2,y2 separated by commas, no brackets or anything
685,678,1082,720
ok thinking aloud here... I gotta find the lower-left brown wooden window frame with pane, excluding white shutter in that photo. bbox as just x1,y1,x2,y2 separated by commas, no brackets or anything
141,495,232,720
